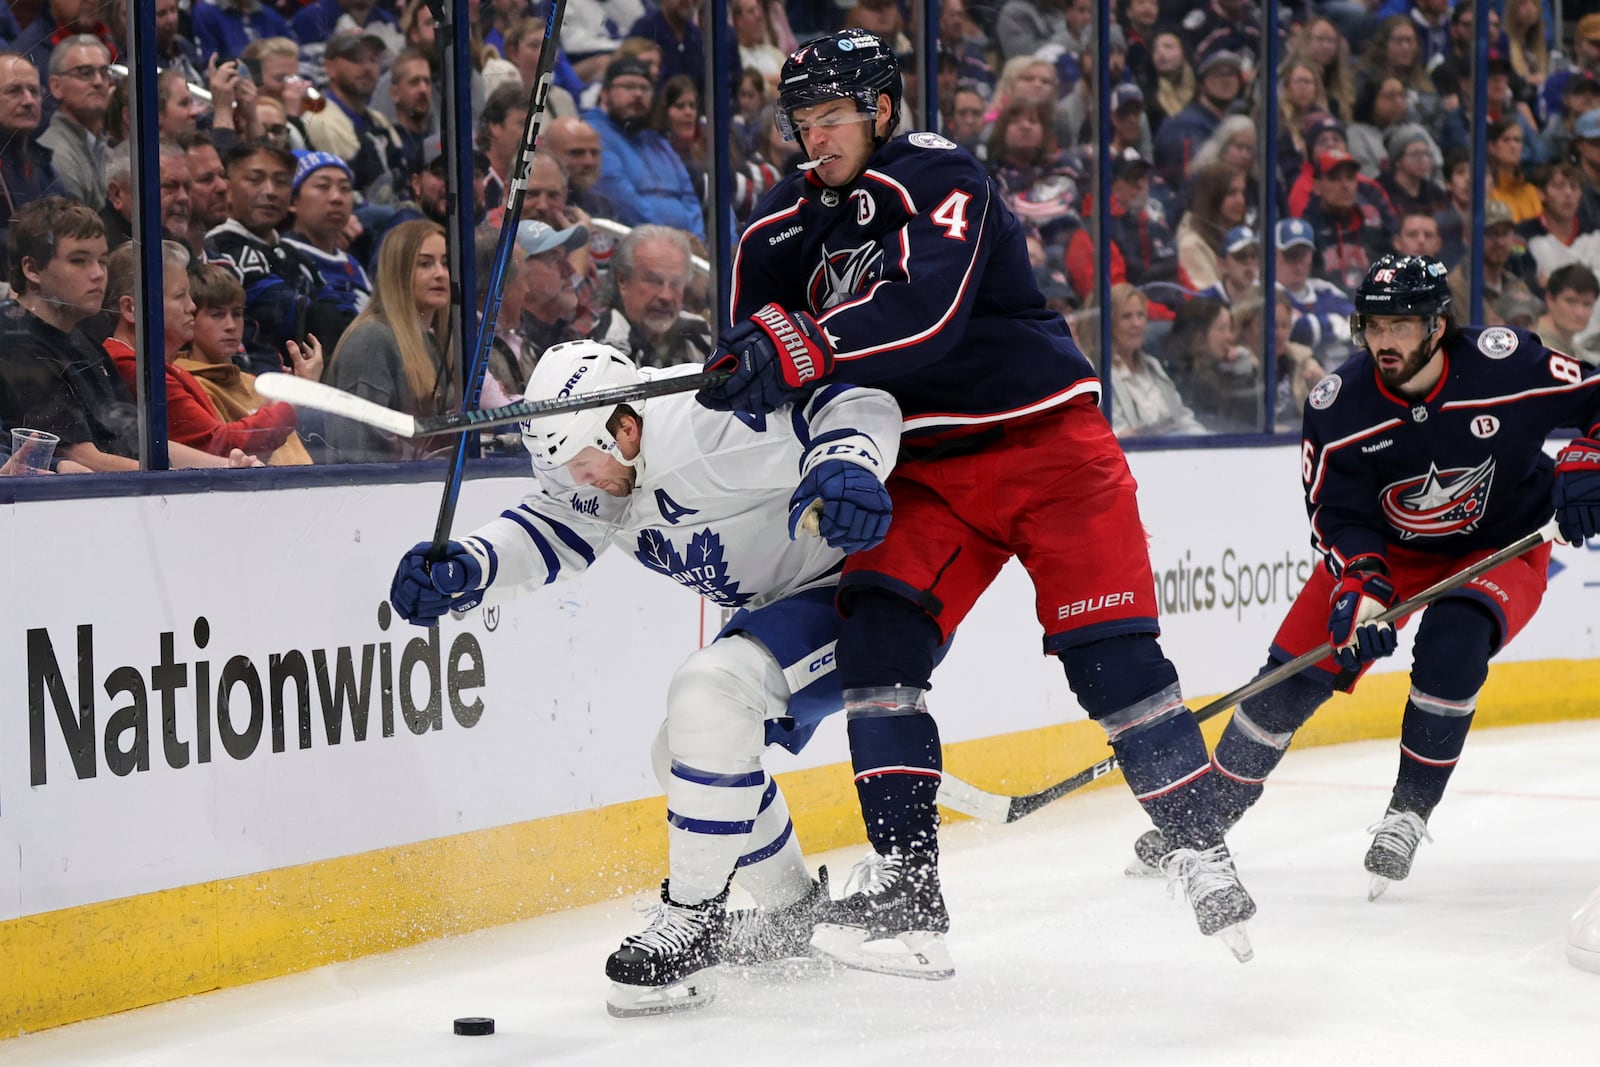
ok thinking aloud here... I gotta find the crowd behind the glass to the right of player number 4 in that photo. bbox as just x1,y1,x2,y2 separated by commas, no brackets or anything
938,0,1600,435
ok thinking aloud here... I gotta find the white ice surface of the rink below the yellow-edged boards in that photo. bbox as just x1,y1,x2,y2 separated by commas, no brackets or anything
0,723,1600,1067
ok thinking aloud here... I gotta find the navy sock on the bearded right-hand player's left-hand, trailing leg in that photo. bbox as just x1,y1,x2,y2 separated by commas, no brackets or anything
1211,661,1333,829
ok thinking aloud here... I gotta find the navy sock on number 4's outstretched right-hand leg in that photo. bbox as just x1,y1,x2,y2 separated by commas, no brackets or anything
1059,633,1222,849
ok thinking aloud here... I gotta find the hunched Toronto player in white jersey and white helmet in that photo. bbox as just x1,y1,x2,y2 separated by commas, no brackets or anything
390,341,901,1016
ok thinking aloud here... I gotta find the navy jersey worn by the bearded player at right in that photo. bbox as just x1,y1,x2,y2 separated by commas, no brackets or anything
1301,326,1600,573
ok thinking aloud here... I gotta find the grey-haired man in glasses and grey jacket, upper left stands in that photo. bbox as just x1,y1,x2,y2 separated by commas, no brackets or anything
38,34,110,211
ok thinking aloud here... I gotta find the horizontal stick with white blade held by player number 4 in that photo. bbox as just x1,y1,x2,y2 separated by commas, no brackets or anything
256,371,728,441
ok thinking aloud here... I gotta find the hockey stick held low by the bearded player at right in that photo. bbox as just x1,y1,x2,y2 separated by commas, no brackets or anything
938,518,1558,822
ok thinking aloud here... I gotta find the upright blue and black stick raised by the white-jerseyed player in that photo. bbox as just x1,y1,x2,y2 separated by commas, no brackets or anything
418,0,566,560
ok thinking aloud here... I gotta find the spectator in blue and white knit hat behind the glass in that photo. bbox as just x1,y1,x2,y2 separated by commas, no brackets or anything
283,152,373,349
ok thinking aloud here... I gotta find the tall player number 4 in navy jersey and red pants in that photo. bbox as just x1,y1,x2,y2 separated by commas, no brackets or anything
701,30,1254,977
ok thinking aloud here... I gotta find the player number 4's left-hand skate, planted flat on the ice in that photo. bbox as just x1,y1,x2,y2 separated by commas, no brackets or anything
811,849,955,979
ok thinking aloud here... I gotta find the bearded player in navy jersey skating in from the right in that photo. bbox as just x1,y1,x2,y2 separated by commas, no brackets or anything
1134,254,1600,899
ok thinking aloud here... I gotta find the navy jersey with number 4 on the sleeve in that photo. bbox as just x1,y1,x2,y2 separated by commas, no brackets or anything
731,133,1099,435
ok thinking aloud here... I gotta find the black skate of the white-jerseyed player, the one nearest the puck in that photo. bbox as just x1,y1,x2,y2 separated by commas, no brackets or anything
605,881,728,1019
